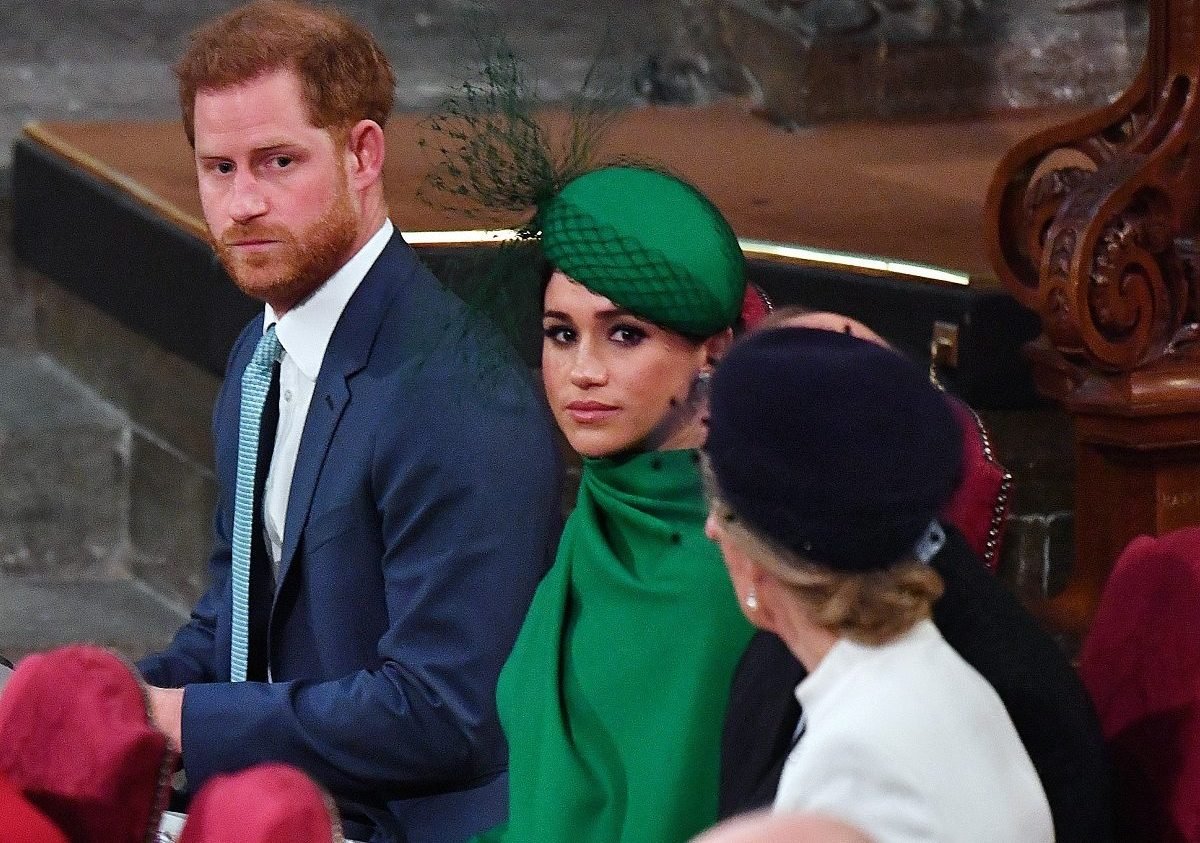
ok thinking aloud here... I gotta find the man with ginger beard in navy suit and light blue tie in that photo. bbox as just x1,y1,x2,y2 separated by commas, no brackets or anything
139,0,559,843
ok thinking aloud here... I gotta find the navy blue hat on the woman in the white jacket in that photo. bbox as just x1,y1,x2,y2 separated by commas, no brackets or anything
704,328,961,572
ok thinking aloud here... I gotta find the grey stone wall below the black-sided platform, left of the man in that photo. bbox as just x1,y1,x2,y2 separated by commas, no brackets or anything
0,169,218,608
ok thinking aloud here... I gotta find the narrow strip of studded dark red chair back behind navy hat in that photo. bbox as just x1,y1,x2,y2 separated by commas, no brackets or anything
942,395,1012,572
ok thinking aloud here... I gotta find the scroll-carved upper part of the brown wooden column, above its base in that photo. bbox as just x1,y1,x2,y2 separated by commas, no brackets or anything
985,0,1200,372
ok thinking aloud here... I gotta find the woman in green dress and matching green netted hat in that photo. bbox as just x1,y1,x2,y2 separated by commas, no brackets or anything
484,167,750,843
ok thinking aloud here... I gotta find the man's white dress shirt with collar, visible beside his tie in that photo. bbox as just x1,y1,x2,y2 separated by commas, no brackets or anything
263,220,394,575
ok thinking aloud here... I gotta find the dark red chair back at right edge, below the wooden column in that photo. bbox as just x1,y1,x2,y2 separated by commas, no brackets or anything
1079,525,1200,843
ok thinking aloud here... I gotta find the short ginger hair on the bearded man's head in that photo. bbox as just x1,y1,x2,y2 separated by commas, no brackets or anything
175,0,395,147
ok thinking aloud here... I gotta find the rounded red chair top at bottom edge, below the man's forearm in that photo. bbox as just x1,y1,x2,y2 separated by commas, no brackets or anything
179,764,342,843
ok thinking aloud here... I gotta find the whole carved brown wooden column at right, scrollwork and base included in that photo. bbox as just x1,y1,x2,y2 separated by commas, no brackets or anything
985,0,1200,634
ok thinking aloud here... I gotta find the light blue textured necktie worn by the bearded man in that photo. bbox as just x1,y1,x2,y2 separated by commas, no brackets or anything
229,325,280,682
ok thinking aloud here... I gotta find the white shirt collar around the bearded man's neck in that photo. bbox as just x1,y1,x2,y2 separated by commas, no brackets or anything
263,219,395,381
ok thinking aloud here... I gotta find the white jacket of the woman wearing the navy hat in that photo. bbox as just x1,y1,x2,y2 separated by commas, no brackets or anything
774,620,1054,843
